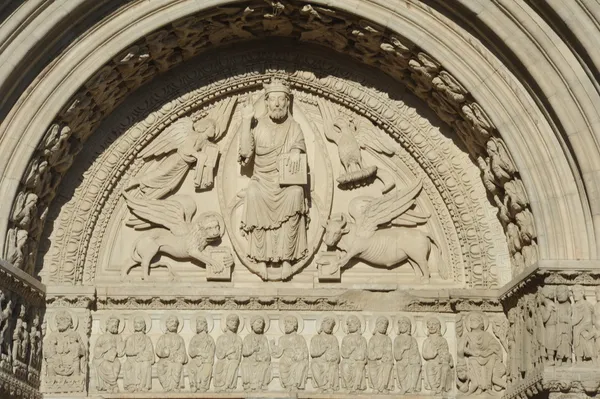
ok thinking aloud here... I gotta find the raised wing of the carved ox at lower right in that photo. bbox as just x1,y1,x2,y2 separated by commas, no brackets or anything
348,180,423,238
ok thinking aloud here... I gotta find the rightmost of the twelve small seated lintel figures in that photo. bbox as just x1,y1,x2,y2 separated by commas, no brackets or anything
423,317,454,395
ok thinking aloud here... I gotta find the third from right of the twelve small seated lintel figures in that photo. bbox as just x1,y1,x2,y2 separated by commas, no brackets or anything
368,316,394,393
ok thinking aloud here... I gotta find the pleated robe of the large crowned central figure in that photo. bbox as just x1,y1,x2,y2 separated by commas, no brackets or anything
240,116,308,263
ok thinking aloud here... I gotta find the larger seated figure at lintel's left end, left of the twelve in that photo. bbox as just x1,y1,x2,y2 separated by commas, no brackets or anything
43,310,87,392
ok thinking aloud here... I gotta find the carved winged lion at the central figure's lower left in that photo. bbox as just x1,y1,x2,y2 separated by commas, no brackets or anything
122,193,233,280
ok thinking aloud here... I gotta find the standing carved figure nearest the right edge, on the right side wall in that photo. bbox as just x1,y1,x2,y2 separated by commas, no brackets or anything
571,285,596,363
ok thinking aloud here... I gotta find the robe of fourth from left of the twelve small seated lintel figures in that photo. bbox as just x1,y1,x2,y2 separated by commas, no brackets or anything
188,332,215,392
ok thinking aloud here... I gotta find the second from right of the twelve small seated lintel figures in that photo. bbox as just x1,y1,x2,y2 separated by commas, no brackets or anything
394,316,421,394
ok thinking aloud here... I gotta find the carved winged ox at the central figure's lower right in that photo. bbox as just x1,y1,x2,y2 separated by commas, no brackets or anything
317,181,448,281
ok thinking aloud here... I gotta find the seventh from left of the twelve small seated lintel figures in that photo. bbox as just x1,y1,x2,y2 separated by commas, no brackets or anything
271,315,308,391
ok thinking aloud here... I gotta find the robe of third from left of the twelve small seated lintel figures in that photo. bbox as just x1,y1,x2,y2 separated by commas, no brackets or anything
156,331,187,391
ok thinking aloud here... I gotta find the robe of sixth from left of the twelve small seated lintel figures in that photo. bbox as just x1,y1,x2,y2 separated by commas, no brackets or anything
242,332,271,391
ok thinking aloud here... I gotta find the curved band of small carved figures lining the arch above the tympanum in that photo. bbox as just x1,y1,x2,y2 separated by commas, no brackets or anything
5,0,537,288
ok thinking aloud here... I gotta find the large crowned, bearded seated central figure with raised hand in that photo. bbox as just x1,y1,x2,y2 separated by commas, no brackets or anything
239,79,308,280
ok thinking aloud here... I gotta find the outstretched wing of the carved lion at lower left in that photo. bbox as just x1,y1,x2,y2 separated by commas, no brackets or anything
123,193,196,236
